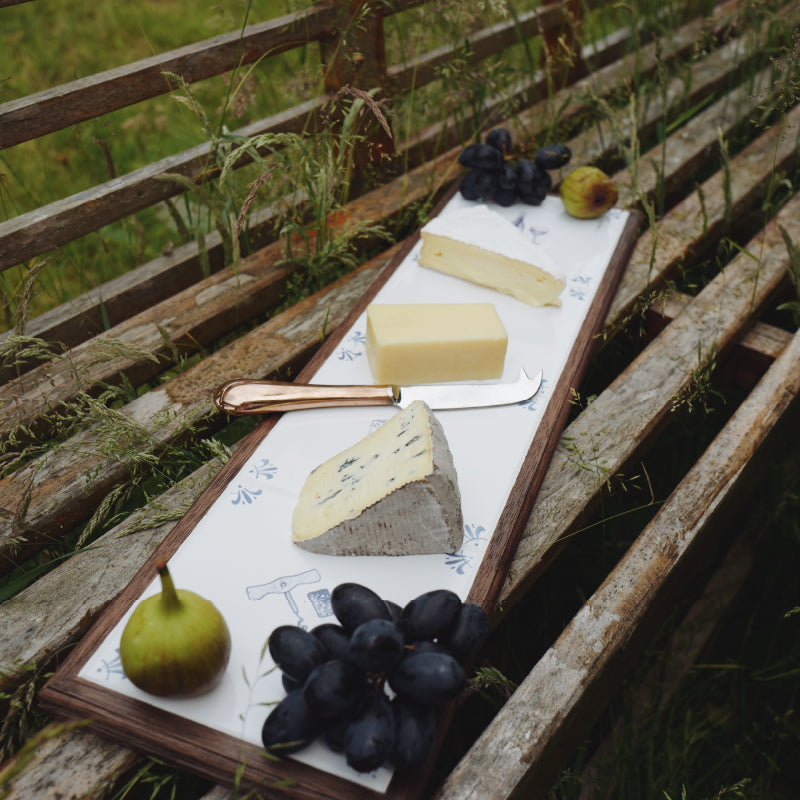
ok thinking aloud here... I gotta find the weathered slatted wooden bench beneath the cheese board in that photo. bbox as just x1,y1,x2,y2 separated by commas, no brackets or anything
0,0,800,800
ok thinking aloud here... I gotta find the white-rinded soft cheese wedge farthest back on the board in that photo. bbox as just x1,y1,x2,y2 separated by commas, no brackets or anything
419,205,564,306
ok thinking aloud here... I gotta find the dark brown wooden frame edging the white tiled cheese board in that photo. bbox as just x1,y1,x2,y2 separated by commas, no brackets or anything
40,185,642,800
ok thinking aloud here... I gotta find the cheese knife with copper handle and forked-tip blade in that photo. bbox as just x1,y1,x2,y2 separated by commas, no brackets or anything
214,369,542,415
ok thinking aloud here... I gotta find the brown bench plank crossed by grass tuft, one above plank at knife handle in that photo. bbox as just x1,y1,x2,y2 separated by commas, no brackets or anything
0,148,450,436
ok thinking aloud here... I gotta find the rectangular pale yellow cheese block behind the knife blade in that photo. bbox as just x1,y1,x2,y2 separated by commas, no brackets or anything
367,303,508,386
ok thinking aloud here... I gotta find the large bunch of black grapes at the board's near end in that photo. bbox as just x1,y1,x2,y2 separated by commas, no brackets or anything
261,583,489,774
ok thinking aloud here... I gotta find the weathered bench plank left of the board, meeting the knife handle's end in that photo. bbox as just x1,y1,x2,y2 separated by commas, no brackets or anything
0,245,392,573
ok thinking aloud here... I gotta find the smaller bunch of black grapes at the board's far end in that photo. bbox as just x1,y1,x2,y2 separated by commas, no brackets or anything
458,128,572,206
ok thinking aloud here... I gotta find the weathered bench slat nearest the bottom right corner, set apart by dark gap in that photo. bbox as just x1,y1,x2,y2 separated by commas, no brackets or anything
436,304,800,800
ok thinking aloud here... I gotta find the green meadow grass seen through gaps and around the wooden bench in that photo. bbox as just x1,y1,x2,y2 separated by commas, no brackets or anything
0,0,800,800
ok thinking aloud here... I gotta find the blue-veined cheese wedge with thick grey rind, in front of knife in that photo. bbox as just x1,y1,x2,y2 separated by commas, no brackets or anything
292,401,464,556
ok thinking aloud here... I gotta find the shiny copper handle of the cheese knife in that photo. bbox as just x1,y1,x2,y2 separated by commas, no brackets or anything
214,378,397,415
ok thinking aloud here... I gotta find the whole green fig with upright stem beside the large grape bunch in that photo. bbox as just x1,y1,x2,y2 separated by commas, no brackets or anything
119,564,231,697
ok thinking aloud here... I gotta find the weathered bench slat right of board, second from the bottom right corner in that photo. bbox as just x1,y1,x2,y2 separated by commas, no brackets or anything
502,189,800,605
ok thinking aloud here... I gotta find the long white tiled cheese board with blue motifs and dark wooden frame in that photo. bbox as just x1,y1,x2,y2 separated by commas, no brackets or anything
42,183,640,798
